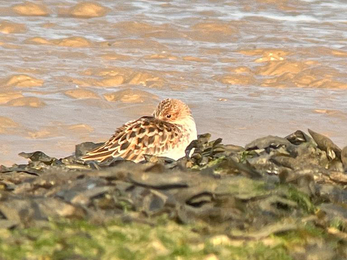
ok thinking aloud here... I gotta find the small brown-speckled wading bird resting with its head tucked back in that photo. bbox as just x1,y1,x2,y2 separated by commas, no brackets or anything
81,99,197,162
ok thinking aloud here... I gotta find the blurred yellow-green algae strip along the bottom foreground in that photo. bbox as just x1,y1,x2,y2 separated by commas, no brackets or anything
0,220,292,260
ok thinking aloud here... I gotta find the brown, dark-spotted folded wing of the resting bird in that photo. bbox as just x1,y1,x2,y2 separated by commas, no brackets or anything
81,116,186,162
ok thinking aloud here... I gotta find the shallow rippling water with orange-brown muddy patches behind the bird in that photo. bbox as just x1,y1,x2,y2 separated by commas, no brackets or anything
0,0,347,164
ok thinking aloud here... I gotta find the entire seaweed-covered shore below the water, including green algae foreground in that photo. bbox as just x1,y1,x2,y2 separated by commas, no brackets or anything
0,130,347,260
